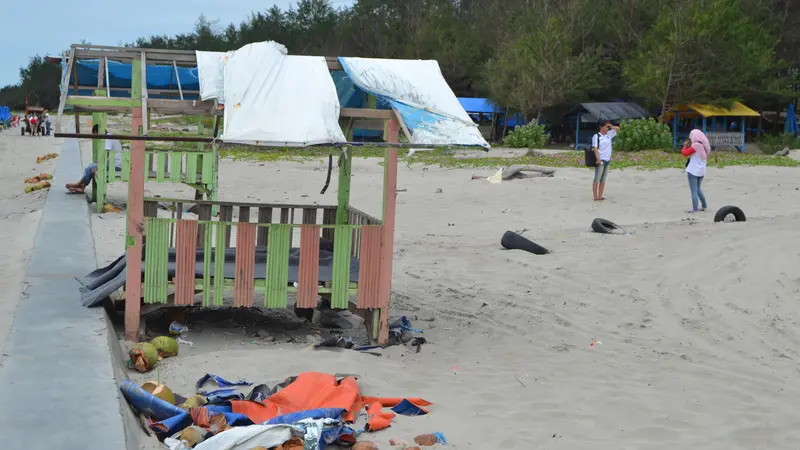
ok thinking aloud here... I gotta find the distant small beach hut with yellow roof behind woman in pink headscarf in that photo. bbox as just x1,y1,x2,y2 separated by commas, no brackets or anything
664,102,759,152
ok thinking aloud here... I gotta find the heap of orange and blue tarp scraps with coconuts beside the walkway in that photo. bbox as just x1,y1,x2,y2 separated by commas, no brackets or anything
120,372,432,450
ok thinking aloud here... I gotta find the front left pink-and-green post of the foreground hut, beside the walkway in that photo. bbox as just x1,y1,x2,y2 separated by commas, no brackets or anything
125,60,145,342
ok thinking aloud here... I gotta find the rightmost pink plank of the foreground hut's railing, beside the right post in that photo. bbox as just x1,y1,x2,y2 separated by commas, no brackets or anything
356,225,389,308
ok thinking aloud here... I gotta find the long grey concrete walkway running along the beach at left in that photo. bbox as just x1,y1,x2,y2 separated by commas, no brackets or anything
0,140,126,450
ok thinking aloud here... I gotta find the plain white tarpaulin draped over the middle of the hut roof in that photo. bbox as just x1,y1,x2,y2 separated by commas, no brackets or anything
222,42,347,147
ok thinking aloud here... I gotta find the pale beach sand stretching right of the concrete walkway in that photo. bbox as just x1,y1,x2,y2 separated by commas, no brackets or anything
84,150,800,450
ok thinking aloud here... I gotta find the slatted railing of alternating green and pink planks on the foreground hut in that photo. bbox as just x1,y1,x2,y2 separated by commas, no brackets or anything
143,198,383,308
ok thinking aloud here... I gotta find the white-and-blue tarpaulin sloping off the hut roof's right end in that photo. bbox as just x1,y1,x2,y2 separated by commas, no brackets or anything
339,57,489,148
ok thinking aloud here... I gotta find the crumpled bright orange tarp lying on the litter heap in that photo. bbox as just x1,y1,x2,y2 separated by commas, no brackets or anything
231,372,431,426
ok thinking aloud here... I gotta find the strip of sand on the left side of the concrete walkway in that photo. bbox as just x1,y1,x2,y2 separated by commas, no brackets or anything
0,128,63,361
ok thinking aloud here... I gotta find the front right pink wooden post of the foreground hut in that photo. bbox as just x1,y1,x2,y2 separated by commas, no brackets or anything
378,119,400,344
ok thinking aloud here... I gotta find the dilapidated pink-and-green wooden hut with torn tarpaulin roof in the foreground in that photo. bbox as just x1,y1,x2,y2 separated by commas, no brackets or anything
55,42,489,344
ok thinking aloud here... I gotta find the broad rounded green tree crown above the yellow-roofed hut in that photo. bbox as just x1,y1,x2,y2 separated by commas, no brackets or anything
623,0,780,111
